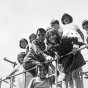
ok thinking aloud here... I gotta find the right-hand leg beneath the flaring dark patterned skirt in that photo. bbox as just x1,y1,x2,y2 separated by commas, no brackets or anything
72,69,79,88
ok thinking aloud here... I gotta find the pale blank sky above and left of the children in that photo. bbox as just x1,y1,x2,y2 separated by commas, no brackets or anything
0,0,88,88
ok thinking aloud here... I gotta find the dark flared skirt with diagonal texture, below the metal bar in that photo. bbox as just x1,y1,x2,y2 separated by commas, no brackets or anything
60,52,86,73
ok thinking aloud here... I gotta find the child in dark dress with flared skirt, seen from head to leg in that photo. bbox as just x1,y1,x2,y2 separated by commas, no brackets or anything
46,30,85,88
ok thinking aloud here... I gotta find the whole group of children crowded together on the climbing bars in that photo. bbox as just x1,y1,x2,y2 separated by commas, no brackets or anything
6,13,88,88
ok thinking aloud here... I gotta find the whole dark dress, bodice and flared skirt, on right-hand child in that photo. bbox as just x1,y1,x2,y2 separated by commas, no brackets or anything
48,37,85,73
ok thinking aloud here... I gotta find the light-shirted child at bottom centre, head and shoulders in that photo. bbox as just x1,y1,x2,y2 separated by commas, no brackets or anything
28,63,58,88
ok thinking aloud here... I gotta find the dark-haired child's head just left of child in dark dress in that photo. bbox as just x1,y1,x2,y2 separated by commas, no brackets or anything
36,28,46,42
